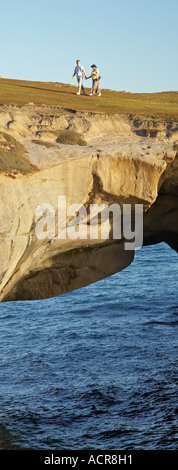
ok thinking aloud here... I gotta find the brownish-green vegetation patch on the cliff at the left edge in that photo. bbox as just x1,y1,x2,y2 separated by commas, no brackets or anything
0,132,37,173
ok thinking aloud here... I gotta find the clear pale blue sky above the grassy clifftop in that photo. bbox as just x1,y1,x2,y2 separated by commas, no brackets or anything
0,0,178,92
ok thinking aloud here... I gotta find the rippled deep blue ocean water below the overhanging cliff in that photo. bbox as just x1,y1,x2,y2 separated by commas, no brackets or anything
0,243,178,450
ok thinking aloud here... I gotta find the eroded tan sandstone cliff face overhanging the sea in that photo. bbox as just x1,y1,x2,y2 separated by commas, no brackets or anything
0,107,178,302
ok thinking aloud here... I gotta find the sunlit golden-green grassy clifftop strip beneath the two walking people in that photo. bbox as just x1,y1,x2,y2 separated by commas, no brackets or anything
0,79,178,121
